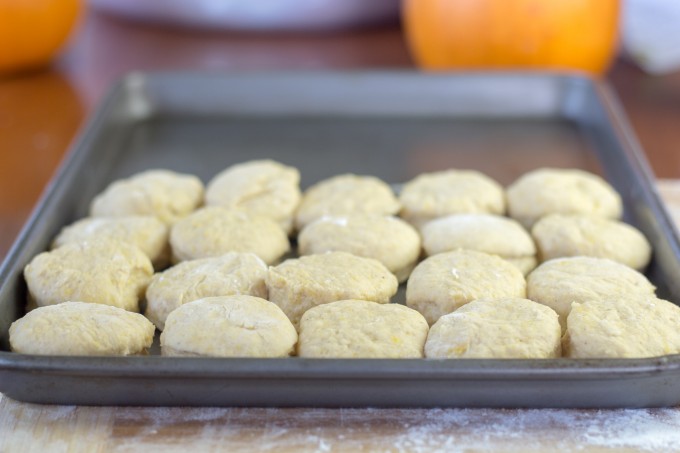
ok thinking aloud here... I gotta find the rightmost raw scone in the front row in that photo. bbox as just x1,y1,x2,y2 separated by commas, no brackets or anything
564,295,680,358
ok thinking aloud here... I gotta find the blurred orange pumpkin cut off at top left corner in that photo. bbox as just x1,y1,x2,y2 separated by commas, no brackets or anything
0,0,81,74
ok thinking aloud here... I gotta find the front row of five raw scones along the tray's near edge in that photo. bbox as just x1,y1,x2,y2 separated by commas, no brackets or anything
10,295,680,359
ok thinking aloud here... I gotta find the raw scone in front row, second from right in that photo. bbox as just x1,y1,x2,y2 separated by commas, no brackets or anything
425,298,562,359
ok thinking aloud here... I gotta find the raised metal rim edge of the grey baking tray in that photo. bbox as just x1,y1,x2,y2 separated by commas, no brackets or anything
0,71,680,406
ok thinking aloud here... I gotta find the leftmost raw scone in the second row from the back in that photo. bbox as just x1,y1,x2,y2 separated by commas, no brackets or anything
52,216,170,269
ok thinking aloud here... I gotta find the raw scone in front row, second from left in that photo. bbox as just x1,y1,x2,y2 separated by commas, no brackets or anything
161,295,297,357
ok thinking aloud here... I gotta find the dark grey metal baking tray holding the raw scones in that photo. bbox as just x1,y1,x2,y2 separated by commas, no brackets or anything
0,72,680,407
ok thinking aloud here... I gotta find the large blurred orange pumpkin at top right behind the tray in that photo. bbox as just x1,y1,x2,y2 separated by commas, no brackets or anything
403,0,619,75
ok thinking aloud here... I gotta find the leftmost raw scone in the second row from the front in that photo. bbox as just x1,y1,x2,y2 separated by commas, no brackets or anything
24,239,153,311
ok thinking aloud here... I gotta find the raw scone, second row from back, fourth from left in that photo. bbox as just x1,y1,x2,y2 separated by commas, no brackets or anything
421,214,536,275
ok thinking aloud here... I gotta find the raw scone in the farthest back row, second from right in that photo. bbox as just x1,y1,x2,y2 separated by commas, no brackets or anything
399,170,505,228
